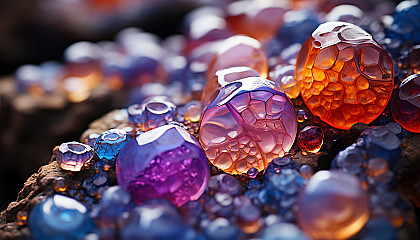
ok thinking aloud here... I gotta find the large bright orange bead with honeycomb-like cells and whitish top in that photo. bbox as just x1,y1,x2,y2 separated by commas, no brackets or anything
296,22,394,129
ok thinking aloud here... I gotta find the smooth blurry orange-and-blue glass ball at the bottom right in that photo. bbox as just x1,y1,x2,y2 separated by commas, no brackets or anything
297,171,369,239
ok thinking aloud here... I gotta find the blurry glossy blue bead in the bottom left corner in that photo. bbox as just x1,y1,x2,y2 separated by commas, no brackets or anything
28,195,94,240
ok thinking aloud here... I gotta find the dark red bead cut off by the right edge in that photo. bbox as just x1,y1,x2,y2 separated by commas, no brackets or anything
391,74,420,133
